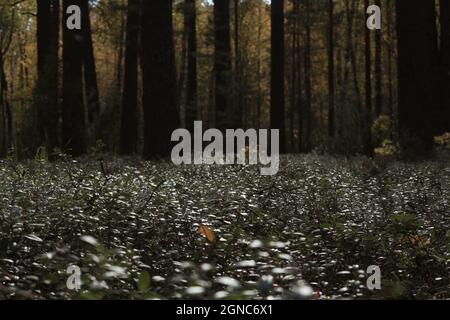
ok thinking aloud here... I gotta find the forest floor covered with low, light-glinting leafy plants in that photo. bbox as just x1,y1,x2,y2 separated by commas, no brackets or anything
0,155,450,299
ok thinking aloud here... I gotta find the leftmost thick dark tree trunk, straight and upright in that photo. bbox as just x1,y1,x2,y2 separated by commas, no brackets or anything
34,0,60,151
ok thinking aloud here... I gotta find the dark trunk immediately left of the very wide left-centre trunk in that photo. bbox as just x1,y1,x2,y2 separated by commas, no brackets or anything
120,0,141,155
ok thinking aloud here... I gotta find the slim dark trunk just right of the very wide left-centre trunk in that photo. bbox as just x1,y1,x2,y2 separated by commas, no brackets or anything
184,0,199,132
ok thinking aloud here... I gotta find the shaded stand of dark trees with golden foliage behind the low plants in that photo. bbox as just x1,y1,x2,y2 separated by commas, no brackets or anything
0,0,450,158
